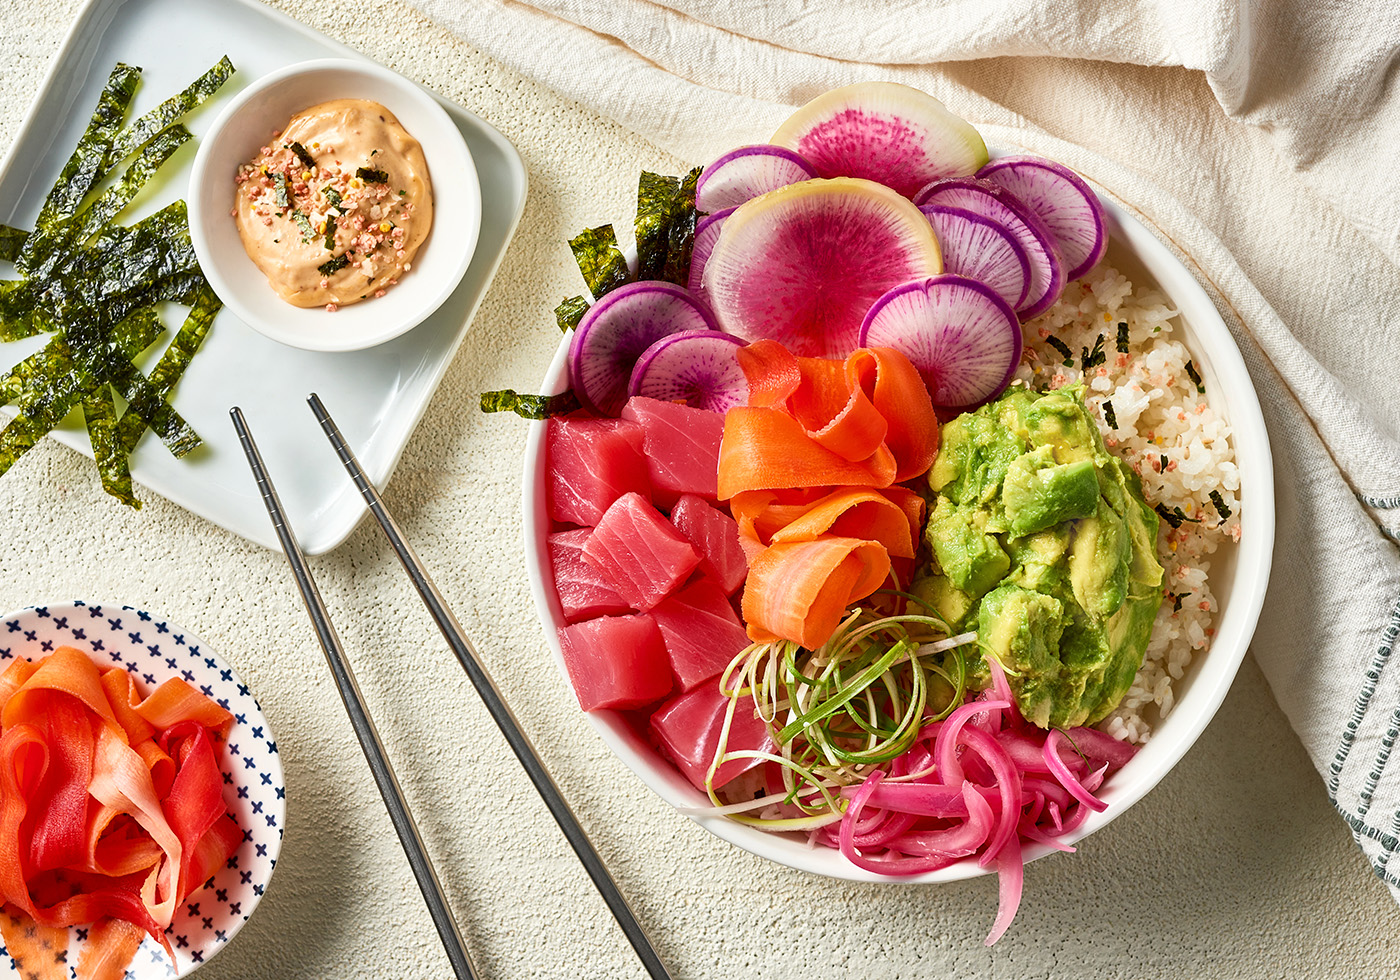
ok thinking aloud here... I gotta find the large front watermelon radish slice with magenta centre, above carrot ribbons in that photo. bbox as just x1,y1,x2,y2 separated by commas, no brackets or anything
703,178,944,357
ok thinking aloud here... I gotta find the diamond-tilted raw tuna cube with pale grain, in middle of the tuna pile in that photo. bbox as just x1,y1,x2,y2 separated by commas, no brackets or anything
584,493,700,612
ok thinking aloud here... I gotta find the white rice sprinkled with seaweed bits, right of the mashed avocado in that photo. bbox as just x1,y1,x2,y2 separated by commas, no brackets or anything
1016,263,1240,743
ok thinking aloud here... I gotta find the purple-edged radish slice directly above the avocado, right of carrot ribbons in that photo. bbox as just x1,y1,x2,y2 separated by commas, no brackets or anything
861,274,1023,409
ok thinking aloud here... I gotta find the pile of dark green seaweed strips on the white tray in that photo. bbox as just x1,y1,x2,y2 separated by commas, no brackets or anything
0,57,234,507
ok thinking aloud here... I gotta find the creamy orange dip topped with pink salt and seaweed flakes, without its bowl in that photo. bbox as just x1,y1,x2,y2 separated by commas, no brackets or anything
232,99,433,312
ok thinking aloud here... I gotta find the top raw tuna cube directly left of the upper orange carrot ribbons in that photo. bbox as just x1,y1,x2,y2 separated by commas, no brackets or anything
622,395,724,510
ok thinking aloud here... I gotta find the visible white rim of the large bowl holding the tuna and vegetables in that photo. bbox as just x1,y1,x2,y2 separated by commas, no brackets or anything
525,191,1274,883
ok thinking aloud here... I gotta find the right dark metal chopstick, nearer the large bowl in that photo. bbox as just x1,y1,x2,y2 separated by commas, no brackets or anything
307,395,671,980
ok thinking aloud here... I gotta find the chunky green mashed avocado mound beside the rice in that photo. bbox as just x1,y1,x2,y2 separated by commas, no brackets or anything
913,385,1162,728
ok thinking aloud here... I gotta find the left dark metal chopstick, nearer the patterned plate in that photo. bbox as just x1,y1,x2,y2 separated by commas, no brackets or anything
230,407,476,980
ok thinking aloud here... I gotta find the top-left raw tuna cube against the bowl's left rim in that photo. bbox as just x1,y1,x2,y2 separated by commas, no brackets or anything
545,419,651,528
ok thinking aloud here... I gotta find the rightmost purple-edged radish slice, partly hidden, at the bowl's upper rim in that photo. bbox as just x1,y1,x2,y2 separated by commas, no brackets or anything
977,157,1109,280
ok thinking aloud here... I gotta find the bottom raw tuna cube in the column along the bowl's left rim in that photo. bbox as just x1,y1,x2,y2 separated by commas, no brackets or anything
559,616,671,711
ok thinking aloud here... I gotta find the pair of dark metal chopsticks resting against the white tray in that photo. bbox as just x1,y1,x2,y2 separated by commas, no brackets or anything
230,395,671,980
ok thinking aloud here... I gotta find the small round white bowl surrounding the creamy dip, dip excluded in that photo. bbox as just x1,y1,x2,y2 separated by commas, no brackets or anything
189,59,482,350
